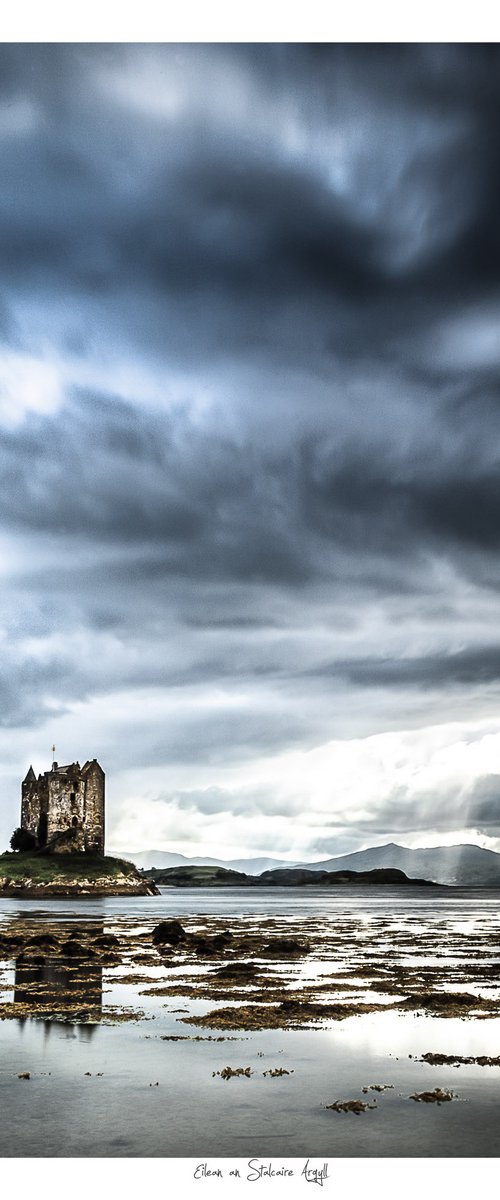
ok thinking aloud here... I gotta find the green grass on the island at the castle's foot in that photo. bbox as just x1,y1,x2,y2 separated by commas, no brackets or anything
0,851,138,883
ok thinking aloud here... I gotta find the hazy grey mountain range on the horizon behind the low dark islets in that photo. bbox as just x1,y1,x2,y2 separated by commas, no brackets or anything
113,841,500,887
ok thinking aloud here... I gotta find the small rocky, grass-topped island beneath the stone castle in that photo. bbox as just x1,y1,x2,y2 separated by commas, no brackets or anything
0,851,157,899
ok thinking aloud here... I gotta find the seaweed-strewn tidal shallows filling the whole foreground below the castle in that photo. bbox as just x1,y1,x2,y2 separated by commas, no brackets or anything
0,887,500,1158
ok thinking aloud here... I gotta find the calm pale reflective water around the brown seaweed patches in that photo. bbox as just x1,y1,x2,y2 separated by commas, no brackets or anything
0,888,500,1159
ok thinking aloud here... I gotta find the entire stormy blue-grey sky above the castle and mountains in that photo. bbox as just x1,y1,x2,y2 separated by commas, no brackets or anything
0,43,500,860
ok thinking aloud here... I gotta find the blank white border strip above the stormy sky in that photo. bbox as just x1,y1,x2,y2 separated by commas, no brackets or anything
0,0,500,42
